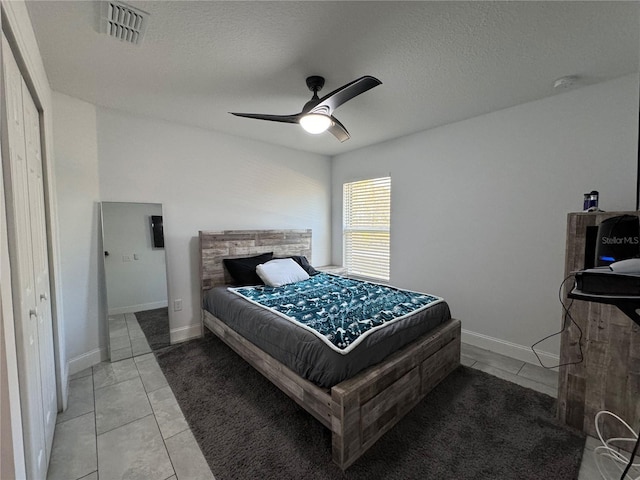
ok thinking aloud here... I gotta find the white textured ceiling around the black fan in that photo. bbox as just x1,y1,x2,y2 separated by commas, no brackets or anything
27,0,640,155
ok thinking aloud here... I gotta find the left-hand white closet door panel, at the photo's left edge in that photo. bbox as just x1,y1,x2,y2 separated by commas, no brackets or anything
2,35,55,479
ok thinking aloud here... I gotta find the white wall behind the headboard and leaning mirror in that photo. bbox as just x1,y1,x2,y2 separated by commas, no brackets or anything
97,108,331,341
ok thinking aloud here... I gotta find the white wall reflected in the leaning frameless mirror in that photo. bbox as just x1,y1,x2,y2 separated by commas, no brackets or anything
102,202,167,315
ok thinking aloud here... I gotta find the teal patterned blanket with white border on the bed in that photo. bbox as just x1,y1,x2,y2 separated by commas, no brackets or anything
229,273,443,354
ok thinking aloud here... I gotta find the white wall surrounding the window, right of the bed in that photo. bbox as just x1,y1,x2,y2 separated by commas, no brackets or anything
332,75,638,362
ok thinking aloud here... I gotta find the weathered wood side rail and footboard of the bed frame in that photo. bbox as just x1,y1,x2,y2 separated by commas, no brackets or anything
203,310,460,470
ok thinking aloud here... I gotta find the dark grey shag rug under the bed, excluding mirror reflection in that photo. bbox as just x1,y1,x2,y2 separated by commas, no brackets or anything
156,332,584,480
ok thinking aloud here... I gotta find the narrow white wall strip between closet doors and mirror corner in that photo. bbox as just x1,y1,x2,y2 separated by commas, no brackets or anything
53,92,102,374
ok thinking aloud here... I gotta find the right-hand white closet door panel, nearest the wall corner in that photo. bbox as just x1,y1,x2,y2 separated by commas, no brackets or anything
22,74,58,458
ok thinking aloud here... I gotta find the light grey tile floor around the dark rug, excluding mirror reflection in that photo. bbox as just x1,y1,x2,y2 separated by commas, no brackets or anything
47,344,619,480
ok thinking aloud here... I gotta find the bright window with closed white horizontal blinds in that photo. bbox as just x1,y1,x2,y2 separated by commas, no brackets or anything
342,177,391,280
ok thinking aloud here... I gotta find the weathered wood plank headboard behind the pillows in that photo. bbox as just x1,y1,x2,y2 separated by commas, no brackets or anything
199,230,311,290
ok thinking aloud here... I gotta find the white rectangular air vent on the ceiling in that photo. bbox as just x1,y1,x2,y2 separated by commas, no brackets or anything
100,1,149,45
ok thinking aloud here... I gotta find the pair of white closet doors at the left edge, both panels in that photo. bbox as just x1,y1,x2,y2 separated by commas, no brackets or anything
2,31,57,479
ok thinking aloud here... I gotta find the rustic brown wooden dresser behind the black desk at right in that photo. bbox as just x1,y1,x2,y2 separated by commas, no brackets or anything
558,212,640,436
